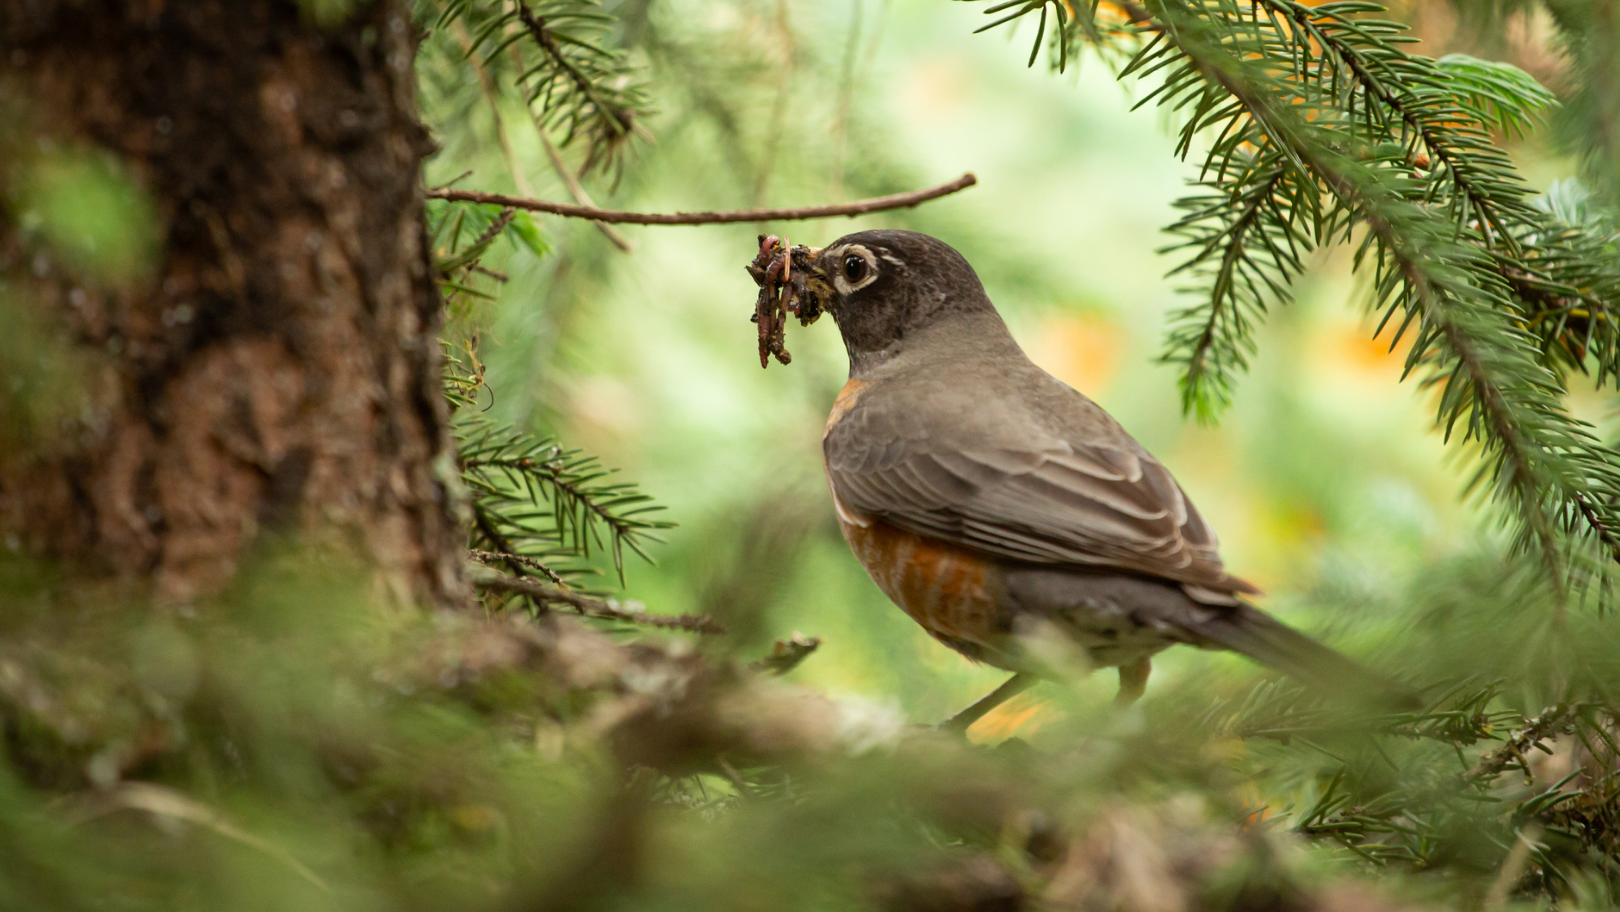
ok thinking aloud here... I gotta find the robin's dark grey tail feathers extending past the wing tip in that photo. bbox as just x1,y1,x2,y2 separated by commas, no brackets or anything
1187,603,1418,708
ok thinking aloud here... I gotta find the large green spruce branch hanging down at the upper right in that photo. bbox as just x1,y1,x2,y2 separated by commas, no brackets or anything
965,0,1620,591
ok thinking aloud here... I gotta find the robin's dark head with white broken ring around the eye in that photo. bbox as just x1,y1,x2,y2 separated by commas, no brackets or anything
807,230,1000,373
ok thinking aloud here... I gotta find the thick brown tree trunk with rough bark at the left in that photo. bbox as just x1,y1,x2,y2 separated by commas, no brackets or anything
0,0,465,603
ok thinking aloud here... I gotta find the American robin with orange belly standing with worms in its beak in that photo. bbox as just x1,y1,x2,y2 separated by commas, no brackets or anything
790,232,1371,727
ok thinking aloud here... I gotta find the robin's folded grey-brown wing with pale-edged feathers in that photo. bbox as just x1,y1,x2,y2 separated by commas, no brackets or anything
823,374,1257,598
